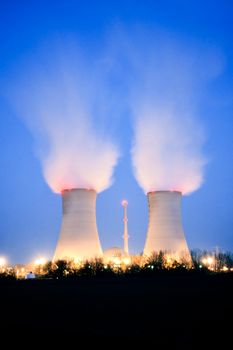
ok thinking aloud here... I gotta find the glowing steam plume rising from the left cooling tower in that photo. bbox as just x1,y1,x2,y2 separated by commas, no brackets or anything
10,42,119,192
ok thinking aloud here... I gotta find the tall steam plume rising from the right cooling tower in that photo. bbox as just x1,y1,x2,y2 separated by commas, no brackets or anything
129,33,221,194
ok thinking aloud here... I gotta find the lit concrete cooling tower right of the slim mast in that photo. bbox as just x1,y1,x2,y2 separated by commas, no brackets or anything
143,191,191,260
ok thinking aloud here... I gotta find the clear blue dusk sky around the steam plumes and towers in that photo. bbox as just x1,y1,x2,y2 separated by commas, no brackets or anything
0,0,233,262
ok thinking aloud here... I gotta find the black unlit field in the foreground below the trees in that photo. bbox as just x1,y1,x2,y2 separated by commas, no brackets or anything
0,273,233,349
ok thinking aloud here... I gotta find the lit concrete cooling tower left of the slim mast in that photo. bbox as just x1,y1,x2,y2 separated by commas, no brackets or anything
53,189,102,261
